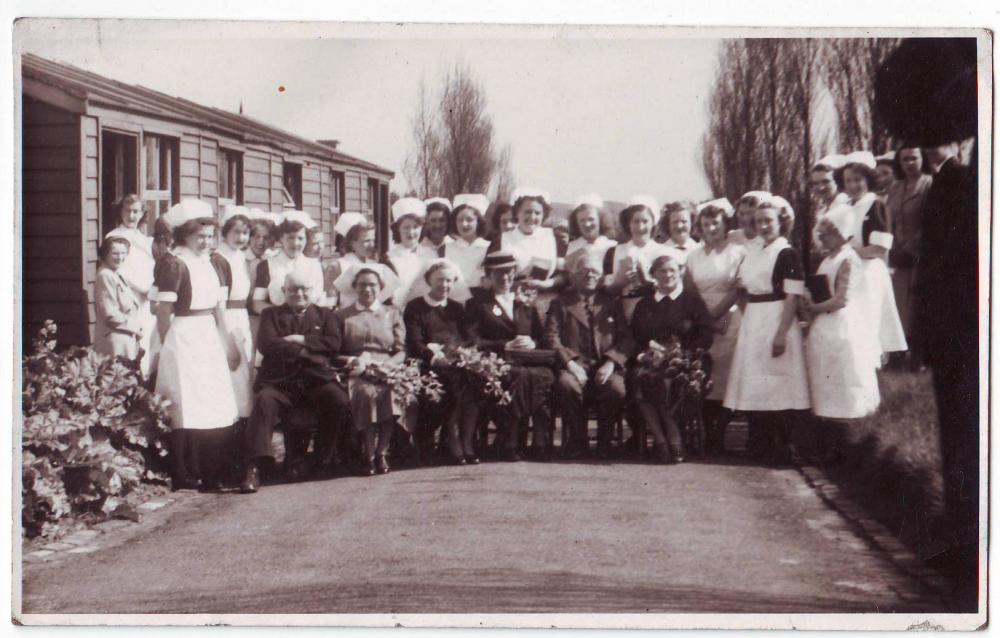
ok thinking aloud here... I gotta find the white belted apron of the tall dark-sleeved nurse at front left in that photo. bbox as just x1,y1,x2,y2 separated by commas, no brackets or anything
156,249,237,430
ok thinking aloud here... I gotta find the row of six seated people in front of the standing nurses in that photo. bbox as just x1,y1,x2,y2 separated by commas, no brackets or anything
240,251,713,492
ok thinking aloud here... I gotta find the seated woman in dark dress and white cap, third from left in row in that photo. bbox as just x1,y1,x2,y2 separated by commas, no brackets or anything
403,259,479,465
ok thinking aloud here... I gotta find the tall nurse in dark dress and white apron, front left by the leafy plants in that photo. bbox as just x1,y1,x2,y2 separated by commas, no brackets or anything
156,200,240,491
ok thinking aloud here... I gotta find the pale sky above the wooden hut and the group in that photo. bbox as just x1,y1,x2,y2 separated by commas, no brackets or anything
15,20,718,202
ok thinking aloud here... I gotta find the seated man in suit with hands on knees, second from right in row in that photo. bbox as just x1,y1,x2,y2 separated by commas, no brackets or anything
545,255,625,458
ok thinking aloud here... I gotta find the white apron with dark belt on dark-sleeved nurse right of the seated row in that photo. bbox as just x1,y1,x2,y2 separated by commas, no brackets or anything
723,237,809,412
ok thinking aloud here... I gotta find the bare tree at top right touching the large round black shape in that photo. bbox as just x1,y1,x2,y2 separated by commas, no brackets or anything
822,38,899,154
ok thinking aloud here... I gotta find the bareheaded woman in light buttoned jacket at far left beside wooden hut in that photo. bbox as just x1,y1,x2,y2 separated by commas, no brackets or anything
94,237,142,360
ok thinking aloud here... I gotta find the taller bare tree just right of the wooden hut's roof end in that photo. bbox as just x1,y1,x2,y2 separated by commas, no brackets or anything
438,63,497,197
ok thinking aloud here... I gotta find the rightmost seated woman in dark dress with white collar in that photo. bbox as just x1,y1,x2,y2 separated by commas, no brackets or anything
615,254,713,463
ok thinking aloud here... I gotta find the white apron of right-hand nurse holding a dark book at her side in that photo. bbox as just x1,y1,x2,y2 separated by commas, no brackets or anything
805,244,879,419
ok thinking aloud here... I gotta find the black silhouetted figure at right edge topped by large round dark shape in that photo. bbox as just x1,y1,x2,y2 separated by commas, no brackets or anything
875,37,987,611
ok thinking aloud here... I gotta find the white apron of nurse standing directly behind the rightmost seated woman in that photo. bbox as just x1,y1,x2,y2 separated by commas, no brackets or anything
687,244,746,401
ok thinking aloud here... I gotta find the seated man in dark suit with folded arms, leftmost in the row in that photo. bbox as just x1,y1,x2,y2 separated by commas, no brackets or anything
240,270,350,493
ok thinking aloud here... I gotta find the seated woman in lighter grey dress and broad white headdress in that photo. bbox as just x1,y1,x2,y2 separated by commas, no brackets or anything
335,264,415,476
